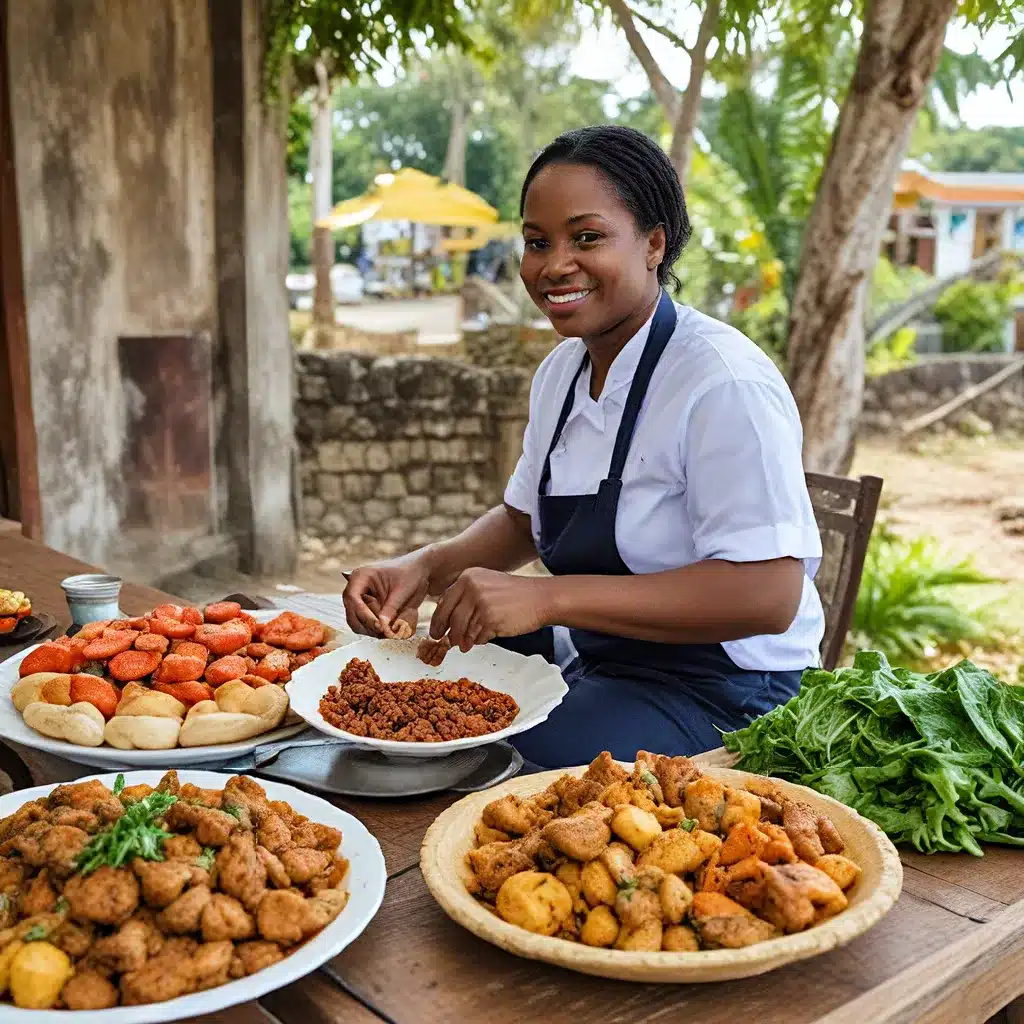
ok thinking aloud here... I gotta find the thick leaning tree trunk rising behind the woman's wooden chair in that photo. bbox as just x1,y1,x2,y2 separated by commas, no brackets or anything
788,0,956,473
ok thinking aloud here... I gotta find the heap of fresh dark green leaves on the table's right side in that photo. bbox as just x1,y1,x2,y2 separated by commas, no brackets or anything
723,651,1024,856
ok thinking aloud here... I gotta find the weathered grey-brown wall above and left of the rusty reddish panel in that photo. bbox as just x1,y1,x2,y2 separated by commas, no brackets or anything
8,0,217,563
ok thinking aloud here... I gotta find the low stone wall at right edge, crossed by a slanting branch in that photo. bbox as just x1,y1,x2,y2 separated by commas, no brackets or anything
861,355,1024,432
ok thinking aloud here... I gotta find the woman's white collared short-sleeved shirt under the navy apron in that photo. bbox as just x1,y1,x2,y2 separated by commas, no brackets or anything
505,305,824,672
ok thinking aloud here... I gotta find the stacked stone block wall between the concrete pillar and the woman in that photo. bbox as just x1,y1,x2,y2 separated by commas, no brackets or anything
295,352,530,553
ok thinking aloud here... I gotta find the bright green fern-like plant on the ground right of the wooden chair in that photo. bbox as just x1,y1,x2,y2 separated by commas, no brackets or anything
850,523,1000,666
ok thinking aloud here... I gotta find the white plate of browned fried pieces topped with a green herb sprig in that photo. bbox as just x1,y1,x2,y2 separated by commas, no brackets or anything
0,770,386,1024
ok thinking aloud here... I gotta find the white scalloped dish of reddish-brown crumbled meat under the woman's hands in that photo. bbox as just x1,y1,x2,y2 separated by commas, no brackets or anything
285,637,568,759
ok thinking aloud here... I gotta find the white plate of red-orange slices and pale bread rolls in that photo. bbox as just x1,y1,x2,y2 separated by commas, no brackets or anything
0,601,335,768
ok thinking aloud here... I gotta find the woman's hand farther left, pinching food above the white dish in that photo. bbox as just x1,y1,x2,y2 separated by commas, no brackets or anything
342,557,430,636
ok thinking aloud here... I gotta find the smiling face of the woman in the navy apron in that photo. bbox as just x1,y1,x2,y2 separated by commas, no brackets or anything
520,164,665,338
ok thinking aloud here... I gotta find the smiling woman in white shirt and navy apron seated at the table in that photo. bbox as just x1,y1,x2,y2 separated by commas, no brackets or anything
345,126,823,767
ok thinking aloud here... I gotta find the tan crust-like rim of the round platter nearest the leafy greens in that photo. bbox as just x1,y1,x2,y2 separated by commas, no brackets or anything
420,764,903,983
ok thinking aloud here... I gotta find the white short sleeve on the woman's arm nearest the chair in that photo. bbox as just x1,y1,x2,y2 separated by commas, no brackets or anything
682,380,821,579
